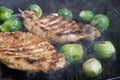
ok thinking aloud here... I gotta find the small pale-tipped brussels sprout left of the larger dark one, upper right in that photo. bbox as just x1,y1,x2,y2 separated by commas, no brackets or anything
79,10,94,21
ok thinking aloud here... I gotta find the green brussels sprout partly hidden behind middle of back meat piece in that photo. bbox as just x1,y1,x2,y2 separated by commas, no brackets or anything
58,8,73,20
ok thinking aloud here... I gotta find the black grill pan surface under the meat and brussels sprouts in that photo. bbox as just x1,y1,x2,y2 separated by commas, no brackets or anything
0,0,120,80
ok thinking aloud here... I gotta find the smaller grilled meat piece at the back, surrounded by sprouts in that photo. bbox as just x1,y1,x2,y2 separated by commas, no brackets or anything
22,10,100,43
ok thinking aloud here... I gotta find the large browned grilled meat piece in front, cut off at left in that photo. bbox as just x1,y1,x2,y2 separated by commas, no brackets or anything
0,31,66,72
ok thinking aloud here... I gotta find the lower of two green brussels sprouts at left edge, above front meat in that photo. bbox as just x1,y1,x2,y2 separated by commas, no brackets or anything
0,17,22,32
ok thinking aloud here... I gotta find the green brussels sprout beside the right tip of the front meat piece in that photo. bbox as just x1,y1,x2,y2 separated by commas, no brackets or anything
60,44,83,63
